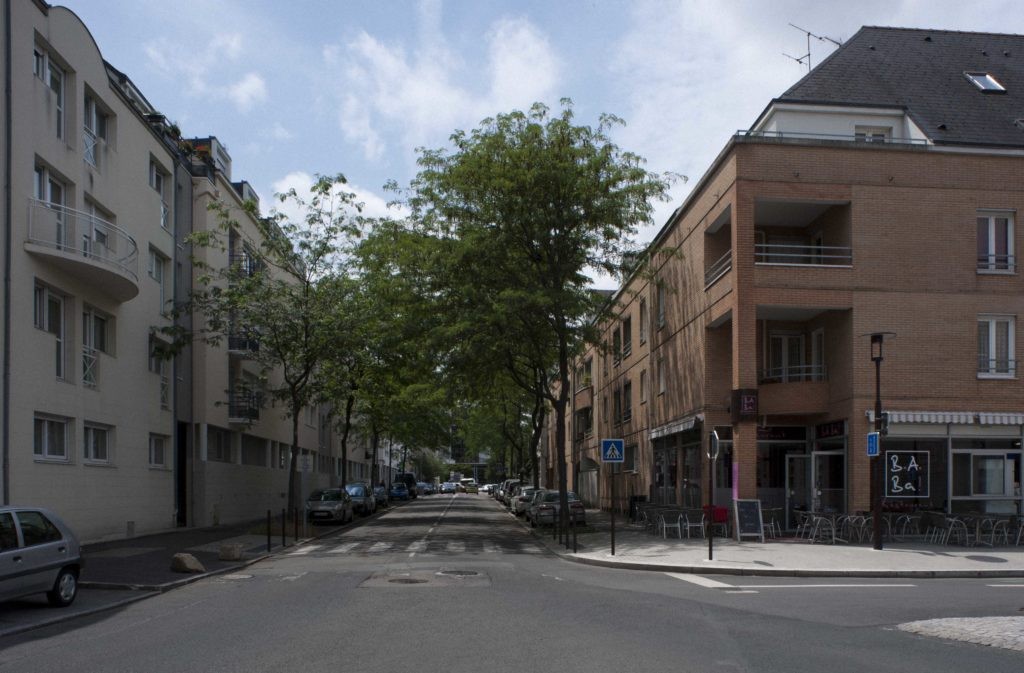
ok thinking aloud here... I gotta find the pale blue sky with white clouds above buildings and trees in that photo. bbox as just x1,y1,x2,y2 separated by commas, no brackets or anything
62,0,1024,287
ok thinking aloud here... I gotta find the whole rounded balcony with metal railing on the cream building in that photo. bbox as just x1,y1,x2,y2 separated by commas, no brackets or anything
25,199,139,302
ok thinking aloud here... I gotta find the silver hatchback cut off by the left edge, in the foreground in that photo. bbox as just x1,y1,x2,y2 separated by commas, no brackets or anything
0,507,84,607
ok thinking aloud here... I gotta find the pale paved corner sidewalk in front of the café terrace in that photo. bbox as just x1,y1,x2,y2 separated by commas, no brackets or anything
535,509,1024,578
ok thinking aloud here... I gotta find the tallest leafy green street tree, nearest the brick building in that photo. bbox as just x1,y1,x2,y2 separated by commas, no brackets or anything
399,99,670,528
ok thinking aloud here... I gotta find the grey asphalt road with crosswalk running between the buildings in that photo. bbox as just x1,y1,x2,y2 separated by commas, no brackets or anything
0,495,1024,673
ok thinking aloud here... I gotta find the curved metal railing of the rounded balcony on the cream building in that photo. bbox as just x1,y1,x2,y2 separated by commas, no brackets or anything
29,199,138,283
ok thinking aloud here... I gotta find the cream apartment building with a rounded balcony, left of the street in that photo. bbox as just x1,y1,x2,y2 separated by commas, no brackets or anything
0,0,374,541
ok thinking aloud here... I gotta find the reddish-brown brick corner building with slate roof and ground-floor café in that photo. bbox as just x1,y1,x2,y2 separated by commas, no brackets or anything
561,28,1024,525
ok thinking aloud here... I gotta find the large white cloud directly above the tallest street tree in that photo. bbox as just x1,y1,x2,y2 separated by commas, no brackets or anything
323,13,562,161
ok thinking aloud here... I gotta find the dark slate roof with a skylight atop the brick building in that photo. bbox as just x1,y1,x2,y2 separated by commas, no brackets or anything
775,27,1024,148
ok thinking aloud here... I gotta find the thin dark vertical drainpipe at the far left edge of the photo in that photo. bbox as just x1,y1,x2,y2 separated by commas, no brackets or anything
2,0,13,505
